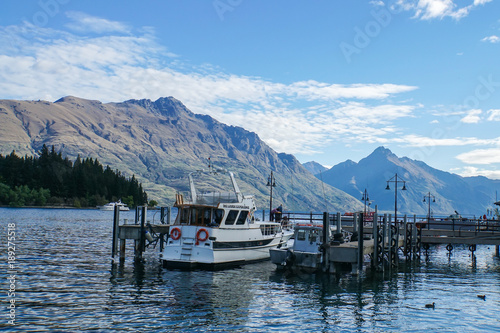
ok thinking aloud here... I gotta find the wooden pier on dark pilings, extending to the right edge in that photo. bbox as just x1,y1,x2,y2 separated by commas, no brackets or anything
284,213,500,274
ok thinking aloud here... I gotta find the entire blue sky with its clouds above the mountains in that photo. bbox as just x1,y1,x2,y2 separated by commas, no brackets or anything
0,0,500,179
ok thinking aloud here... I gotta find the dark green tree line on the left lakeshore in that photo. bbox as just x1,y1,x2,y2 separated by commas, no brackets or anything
0,145,148,207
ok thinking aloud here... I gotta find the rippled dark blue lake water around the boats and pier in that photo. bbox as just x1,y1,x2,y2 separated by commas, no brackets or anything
0,208,500,332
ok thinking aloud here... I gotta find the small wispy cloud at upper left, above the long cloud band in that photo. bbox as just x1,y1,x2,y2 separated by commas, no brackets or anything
66,11,130,33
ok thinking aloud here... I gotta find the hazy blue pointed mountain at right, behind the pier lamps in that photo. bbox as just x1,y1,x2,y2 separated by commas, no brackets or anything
316,147,500,216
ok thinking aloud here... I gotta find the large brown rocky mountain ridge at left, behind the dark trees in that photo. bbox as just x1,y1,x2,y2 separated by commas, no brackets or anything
0,96,361,212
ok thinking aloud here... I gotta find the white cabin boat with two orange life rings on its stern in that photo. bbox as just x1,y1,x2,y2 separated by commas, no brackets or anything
160,169,293,269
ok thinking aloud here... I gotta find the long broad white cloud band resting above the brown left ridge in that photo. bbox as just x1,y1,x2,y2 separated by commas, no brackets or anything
0,24,417,153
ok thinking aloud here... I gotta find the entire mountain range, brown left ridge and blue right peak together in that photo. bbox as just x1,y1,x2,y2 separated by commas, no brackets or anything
0,96,500,215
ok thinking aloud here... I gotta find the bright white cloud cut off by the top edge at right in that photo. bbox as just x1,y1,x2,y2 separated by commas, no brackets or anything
397,0,492,20
